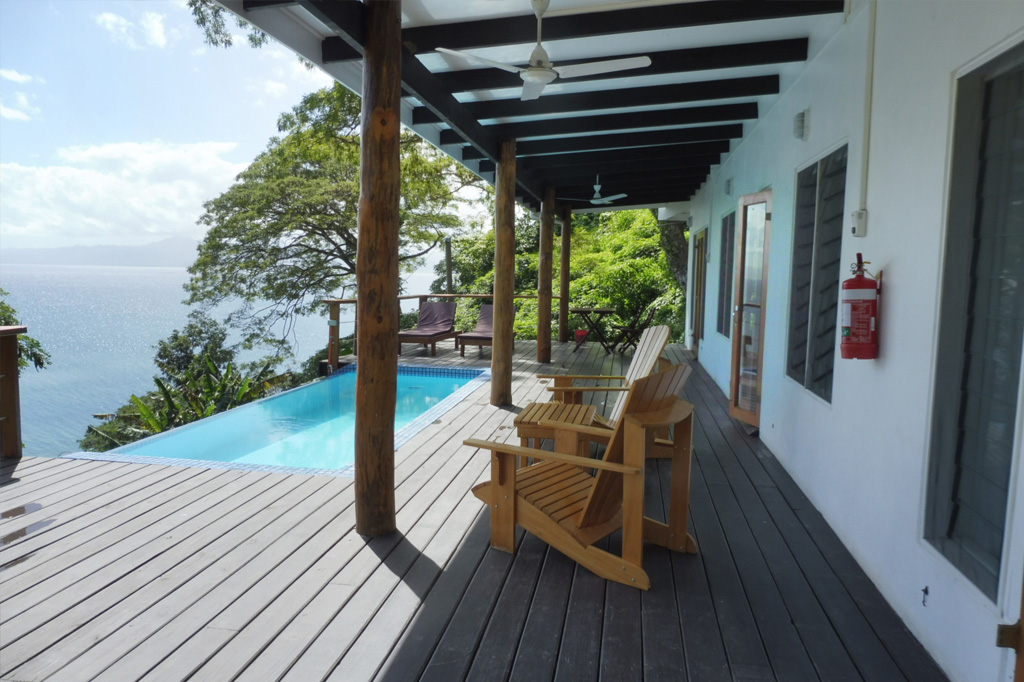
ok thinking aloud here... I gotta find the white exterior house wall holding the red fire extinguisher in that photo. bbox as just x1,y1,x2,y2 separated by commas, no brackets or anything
689,0,1024,682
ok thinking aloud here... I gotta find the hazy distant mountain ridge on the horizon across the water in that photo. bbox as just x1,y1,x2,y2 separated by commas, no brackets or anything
0,237,199,267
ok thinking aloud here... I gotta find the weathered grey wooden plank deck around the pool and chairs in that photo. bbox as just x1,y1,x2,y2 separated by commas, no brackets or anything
0,342,945,682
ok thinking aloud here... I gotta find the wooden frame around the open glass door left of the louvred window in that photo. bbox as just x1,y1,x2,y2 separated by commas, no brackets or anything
729,189,772,428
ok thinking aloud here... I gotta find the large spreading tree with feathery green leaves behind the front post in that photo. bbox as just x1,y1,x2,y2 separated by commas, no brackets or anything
185,85,481,354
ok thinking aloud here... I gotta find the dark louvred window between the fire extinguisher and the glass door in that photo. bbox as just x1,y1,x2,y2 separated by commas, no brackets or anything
786,145,847,400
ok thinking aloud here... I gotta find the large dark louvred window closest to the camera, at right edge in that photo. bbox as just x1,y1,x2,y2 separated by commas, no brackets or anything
925,48,1024,600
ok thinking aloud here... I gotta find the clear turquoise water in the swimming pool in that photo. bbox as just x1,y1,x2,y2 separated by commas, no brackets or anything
90,366,489,472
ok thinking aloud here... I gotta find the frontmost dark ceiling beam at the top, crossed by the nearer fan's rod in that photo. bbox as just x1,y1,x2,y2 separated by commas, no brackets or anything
402,0,845,55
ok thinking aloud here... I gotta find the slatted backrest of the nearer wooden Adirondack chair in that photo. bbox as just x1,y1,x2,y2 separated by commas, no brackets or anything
579,363,693,527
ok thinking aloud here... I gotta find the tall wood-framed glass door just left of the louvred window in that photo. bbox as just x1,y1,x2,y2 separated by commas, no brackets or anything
729,190,771,427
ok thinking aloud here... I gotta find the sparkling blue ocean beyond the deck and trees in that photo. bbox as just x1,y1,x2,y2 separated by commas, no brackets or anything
0,263,434,456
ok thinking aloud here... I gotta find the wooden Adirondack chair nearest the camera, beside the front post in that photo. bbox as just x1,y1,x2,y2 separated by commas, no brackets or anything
465,365,697,590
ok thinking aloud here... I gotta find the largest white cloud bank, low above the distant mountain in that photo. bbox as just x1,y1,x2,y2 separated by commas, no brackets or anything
0,141,245,246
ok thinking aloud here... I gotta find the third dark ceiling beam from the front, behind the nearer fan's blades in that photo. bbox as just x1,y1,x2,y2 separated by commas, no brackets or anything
413,72,779,124
